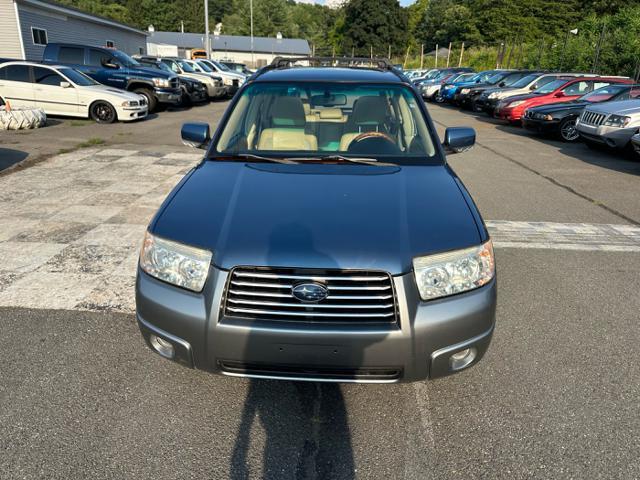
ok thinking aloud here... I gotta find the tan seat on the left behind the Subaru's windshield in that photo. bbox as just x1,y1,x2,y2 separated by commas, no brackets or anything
258,97,318,150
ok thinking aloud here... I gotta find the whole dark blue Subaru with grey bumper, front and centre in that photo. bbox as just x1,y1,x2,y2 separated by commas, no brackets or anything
136,59,496,383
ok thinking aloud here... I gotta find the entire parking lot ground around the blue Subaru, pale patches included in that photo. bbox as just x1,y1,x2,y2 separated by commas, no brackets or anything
0,103,640,479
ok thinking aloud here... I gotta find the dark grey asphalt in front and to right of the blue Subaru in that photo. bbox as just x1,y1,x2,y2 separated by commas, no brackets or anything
0,100,640,479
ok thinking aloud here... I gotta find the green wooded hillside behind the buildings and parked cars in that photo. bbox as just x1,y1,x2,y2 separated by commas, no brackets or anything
60,0,640,75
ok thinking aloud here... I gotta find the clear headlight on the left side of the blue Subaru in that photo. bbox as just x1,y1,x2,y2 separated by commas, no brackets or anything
140,232,213,292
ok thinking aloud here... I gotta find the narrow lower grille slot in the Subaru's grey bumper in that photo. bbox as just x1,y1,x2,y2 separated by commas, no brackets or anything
218,361,402,382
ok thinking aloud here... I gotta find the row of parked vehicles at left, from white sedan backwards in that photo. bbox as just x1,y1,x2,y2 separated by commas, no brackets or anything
0,43,252,123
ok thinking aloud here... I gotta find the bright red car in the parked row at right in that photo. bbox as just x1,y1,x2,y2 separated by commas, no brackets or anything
495,77,633,123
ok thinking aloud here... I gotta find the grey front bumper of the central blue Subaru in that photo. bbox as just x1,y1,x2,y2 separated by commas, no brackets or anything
136,267,497,383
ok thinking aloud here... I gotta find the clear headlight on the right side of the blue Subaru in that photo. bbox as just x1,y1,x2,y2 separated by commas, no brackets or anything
413,240,495,300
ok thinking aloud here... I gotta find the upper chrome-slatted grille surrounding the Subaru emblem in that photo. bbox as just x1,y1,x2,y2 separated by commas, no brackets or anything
224,267,398,324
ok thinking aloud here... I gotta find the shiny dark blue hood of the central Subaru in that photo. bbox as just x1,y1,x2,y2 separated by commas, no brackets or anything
151,161,486,274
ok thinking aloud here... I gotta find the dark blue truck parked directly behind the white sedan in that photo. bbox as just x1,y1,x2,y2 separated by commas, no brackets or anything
43,43,182,112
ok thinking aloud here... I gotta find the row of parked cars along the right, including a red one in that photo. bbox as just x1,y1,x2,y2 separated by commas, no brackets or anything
413,69,640,153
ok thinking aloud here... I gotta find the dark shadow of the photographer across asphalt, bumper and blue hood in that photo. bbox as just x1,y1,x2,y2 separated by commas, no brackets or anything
230,222,387,480
